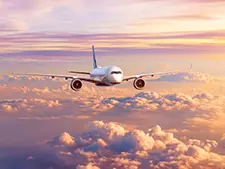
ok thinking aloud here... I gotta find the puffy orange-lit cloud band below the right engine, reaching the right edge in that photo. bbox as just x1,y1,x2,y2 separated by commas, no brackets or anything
88,92,225,111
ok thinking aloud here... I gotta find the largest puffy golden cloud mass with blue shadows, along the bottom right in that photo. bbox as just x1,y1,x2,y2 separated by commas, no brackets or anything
45,121,225,169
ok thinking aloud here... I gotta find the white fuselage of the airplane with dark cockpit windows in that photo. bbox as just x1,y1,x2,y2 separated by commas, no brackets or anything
90,66,123,86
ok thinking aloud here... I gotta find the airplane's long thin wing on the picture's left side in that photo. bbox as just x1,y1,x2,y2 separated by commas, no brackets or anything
13,73,102,83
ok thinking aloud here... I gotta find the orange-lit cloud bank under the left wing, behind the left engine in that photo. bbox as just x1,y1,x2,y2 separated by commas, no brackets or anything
0,75,130,100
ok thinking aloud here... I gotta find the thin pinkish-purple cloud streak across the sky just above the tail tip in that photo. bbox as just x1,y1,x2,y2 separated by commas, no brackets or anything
1,29,225,41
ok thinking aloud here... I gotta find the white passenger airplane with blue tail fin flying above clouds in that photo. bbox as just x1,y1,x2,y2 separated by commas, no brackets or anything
16,45,179,91
